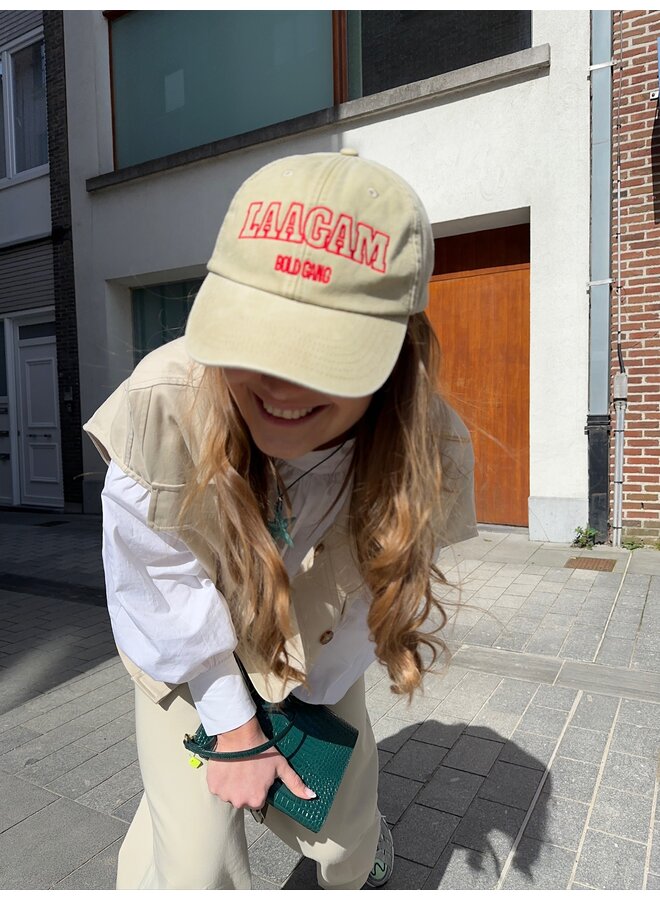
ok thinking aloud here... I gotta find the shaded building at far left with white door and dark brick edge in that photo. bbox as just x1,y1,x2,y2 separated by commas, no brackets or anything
0,11,82,510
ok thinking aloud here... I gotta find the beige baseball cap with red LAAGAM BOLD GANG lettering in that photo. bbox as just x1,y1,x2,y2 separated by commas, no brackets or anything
185,149,433,397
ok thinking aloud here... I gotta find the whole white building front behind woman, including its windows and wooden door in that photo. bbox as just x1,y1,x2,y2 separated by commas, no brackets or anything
64,11,592,541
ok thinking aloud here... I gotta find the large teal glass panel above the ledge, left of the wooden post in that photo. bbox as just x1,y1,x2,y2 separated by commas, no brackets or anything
111,10,333,168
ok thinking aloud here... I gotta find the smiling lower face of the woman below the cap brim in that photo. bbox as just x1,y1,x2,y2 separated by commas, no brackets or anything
223,369,372,459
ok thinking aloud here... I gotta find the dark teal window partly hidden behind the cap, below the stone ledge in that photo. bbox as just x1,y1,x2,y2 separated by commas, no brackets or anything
131,278,202,363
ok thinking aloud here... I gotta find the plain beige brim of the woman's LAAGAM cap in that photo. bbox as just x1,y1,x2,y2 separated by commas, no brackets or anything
185,273,408,397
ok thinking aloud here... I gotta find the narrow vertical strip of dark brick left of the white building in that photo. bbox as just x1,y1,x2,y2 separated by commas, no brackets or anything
43,11,82,504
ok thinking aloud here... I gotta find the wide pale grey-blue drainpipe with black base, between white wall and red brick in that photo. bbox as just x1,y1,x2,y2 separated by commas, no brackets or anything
585,10,612,543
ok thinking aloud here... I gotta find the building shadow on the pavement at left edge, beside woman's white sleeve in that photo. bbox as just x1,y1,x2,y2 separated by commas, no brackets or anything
0,510,116,713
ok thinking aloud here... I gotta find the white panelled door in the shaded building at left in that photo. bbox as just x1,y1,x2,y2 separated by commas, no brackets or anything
16,322,64,507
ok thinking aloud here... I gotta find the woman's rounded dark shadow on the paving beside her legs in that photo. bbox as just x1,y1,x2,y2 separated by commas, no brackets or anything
379,720,565,890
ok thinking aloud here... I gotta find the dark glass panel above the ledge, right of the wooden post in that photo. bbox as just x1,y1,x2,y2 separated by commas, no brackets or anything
348,10,532,99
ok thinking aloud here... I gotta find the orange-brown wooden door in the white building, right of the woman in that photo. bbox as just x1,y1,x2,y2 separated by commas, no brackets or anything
428,246,529,525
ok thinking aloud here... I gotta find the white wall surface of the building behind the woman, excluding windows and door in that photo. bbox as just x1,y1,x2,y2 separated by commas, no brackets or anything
64,11,590,541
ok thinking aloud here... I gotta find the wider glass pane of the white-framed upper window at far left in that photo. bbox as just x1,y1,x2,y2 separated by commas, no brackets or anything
11,41,48,172
